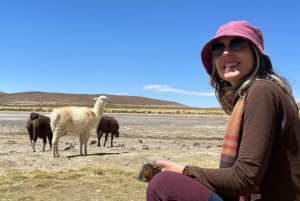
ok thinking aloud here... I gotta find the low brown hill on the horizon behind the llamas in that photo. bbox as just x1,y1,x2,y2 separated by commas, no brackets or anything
0,91,185,106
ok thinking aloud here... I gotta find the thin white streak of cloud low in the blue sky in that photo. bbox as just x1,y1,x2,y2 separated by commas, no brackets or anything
142,85,215,96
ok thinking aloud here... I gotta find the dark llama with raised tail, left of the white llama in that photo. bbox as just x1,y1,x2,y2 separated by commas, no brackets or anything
26,112,53,152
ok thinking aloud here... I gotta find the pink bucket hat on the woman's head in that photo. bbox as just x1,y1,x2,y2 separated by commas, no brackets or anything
201,21,270,75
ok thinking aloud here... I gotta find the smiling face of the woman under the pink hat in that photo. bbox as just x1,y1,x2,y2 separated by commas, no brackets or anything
213,36,255,86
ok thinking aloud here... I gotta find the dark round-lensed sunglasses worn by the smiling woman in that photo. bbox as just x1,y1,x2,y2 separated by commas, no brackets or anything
210,37,246,57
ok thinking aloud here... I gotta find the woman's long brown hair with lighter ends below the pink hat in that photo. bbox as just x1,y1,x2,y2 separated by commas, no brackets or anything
209,42,299,114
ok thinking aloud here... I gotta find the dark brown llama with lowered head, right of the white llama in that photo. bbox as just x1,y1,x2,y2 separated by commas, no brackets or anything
96,116,119,147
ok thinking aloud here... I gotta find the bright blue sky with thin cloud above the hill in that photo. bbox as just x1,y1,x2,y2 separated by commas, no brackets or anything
0,0,300,107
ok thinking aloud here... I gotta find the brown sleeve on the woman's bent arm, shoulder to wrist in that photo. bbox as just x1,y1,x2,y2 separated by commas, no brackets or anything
188,81,280,196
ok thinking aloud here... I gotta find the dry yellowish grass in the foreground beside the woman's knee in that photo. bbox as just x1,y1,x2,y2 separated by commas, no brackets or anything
0,150,218,201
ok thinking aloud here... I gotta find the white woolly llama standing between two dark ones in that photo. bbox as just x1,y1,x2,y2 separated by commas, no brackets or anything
50,96,109,158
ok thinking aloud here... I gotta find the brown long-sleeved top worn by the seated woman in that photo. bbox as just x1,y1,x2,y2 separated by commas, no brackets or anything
188,80,300,201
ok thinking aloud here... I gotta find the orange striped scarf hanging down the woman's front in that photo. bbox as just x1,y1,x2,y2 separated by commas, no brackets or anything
220,94,247,201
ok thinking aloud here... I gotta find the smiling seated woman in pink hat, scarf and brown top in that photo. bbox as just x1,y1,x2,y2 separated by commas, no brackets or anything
147,21,300,201
